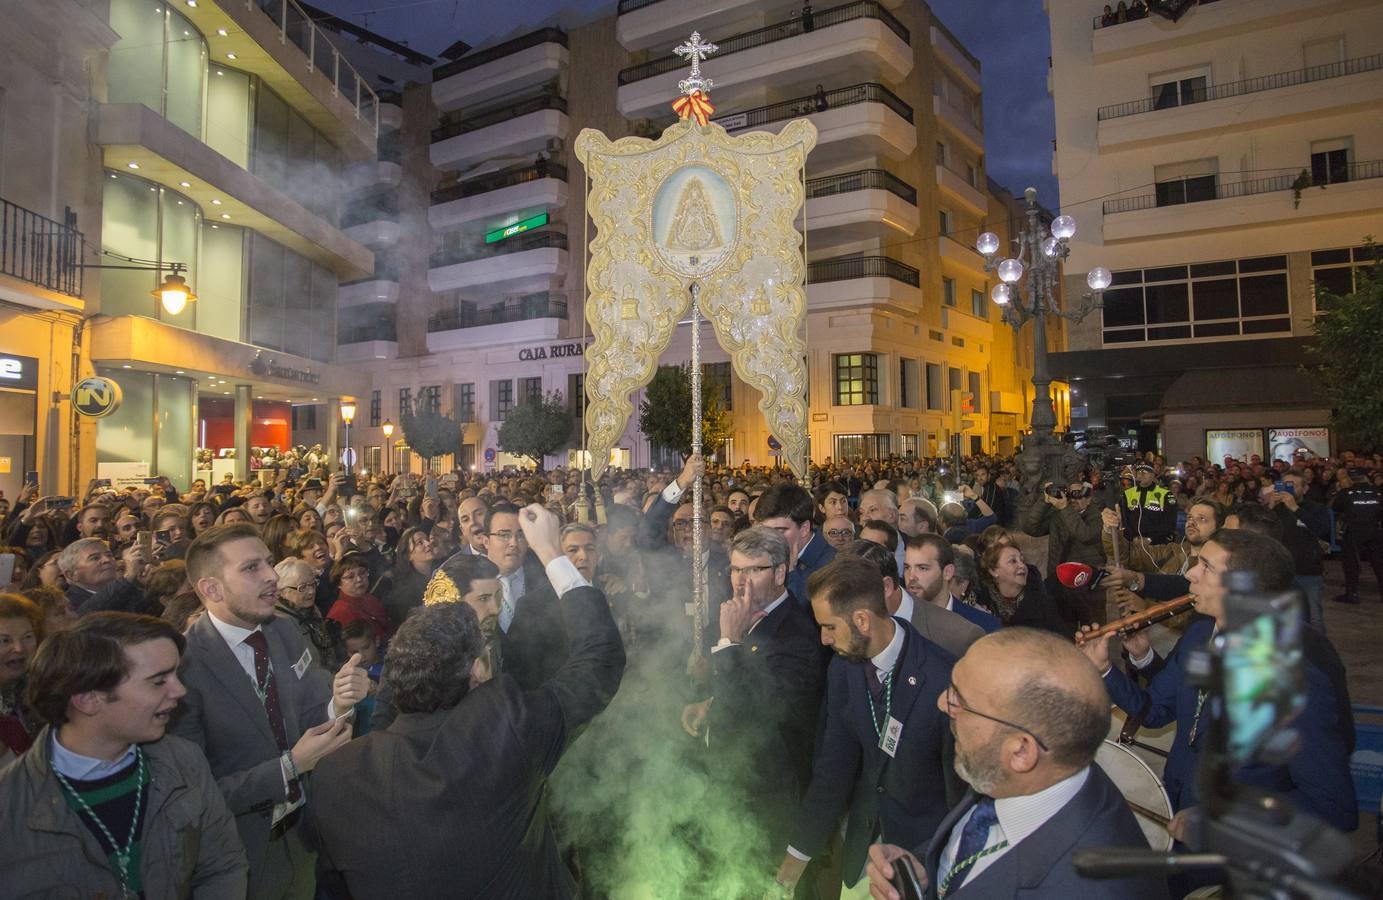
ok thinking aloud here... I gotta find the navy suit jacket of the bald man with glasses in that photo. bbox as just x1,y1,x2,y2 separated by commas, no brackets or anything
924,765,1167,900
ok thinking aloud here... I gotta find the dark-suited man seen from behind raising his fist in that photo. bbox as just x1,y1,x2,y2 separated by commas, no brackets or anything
313,505,624,900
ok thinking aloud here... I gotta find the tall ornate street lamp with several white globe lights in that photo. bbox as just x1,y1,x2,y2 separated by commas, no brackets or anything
975,188,1112,498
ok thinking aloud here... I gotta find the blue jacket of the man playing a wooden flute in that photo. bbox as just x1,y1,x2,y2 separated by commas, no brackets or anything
1105,615,1358,831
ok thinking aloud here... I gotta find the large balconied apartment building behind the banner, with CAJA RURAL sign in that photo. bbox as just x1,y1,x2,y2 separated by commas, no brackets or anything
365,0,1056,467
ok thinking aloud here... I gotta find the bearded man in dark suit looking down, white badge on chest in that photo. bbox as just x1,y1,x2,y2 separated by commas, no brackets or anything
777,555,956,888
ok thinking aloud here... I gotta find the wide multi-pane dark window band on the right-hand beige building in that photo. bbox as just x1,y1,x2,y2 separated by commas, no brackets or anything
1104,256,1292,344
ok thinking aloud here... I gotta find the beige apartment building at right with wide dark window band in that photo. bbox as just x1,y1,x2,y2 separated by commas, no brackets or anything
1047,0,1383,459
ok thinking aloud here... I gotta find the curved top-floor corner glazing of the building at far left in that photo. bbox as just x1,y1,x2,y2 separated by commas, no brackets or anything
106,0,206,137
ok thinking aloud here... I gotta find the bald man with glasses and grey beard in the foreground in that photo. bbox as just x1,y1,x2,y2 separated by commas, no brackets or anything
867,628,1167,900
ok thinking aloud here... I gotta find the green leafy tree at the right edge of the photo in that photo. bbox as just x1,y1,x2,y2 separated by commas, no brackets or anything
1314,248,1383,451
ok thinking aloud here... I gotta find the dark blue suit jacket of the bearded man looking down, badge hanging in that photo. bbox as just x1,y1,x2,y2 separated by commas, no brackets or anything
792,618,956,885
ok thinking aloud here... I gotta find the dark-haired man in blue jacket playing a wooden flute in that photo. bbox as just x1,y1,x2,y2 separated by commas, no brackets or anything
1083,528,1358,839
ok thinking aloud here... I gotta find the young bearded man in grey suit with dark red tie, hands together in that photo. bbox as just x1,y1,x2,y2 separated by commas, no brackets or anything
173,524,369,900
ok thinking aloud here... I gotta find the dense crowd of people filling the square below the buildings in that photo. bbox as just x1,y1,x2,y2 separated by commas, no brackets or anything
0,452,1383,899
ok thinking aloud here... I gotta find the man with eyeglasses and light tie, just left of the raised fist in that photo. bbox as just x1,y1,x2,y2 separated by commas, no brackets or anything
484,503,555,690
